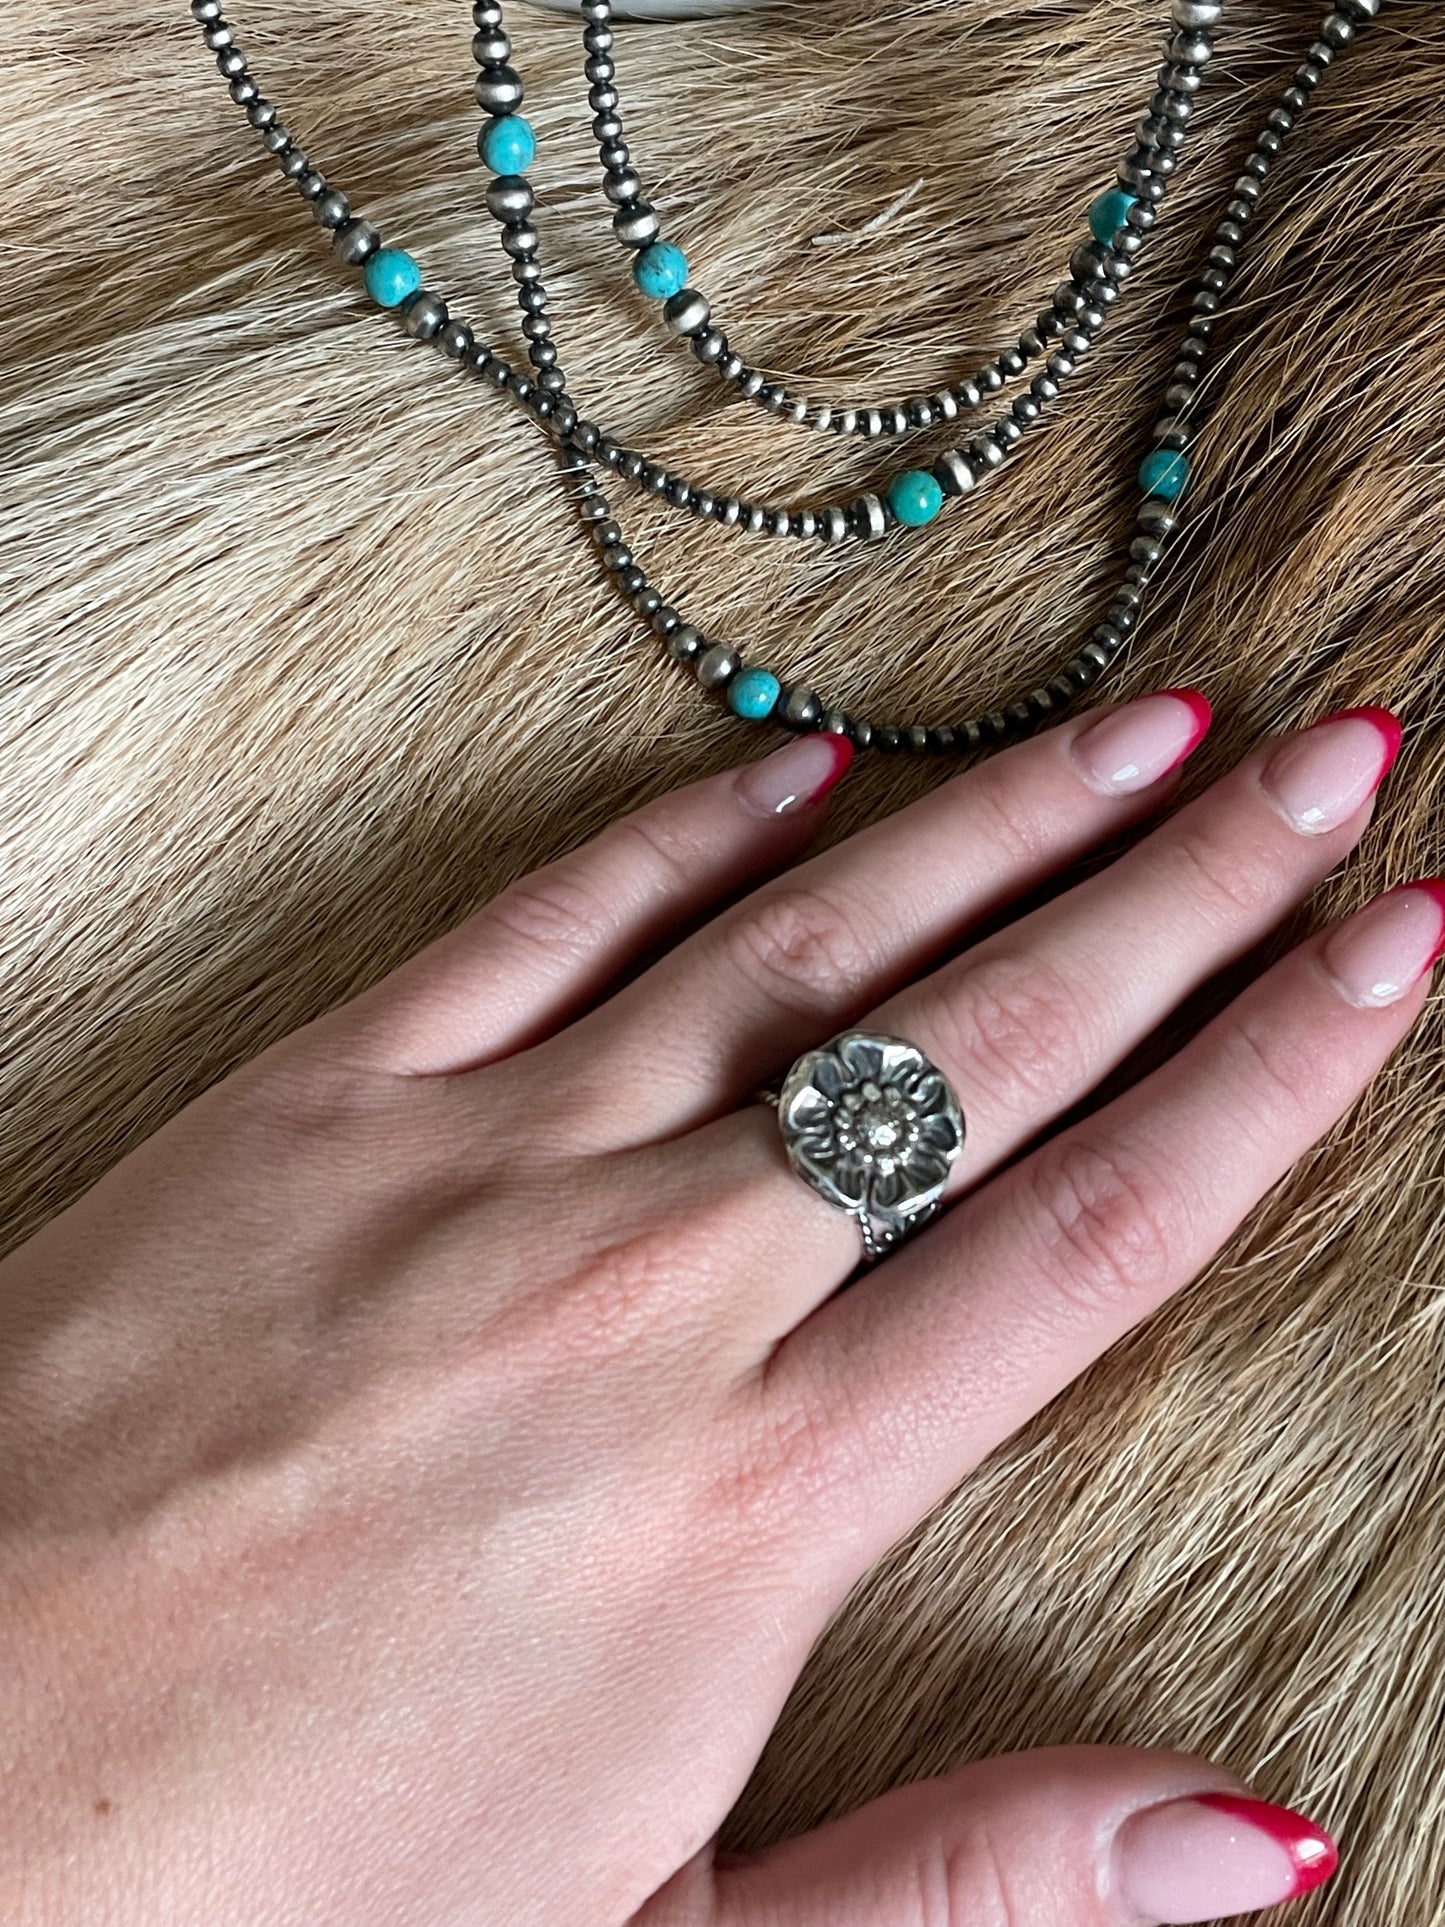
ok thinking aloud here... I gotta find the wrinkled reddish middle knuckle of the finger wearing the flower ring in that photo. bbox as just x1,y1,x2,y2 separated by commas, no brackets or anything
927,954,1090,1104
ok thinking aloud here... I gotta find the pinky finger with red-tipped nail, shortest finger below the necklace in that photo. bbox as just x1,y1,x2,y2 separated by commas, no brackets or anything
302,734,854,1077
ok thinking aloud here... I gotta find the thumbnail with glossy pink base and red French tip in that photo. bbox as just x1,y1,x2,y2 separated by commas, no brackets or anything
1114,1794,1339,1927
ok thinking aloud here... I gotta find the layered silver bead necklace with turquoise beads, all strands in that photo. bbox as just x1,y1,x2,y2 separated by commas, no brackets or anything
191,0,1381,755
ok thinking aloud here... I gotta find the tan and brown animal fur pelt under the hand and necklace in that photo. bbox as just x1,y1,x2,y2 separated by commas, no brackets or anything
0,0,1445,1927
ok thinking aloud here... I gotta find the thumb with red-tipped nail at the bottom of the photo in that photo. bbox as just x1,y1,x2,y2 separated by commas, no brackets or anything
642,1746,1337,1927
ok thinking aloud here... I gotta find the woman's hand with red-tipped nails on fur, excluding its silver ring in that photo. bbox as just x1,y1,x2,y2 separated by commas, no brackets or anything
0,694,1445,1927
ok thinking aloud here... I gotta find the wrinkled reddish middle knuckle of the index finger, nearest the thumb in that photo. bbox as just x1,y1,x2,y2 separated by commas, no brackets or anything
1031,1137,1181,1316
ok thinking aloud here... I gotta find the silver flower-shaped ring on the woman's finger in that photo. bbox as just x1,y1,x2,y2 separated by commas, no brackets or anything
759,1031,965,1264
